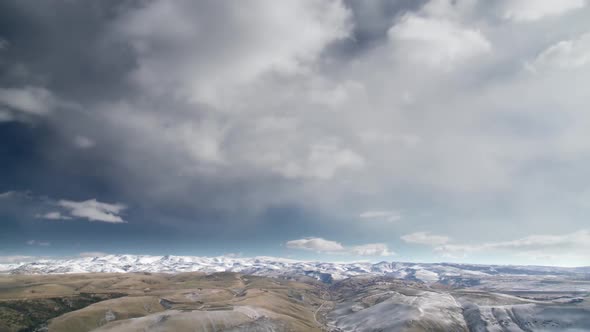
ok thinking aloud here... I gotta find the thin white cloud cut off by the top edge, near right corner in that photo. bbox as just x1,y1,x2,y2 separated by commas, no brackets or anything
501,0,586,22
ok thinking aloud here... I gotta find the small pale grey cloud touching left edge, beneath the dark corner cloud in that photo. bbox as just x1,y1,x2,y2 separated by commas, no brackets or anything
0,86,58,115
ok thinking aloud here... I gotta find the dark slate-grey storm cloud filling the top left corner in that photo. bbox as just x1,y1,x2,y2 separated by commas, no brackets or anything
0,0,133,100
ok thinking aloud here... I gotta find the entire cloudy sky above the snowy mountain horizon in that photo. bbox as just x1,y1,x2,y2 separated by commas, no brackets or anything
0,0,590,266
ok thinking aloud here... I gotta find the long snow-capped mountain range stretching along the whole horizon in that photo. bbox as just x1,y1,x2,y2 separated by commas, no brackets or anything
0,255,588,284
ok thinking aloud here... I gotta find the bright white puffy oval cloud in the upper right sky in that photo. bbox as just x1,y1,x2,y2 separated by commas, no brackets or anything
387,14,492,69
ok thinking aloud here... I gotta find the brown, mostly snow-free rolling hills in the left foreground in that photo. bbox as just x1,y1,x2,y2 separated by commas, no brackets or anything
0,273,324,332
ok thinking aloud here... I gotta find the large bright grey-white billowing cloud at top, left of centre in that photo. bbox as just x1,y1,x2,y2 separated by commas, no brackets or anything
114,0,351,108
